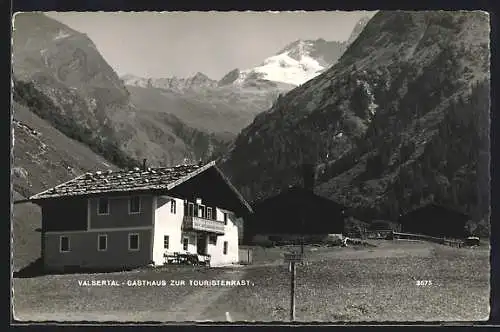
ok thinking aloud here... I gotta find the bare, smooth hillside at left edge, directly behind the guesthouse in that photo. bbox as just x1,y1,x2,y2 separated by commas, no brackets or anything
11,102,117,270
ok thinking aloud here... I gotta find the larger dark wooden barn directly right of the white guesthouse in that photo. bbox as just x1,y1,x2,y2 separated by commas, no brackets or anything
244,187,344,240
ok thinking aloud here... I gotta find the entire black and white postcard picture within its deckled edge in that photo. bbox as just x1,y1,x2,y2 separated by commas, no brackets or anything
11,11,490,323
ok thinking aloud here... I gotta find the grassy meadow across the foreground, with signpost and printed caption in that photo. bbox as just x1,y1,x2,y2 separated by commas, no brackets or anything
13,241,490,322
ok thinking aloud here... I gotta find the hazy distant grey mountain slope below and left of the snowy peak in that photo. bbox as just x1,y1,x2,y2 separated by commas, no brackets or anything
121,73,294,132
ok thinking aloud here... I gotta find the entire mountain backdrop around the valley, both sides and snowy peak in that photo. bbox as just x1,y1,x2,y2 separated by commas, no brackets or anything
12,12,490,274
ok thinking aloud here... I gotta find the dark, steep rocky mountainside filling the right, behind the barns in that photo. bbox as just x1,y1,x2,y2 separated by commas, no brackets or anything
220,11,489,233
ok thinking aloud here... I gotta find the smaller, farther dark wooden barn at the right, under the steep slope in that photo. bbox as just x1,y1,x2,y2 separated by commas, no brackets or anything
399,203,471,238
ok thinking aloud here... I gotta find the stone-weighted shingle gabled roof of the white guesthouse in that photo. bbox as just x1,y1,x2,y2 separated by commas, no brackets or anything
28,161,252,211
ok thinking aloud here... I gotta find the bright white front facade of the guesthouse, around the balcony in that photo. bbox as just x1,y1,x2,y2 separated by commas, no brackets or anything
153,196,238,266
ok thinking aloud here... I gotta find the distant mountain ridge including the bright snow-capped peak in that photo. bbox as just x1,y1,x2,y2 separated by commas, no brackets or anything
121,18,367,139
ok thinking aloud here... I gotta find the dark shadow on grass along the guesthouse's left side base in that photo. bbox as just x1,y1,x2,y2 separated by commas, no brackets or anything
14,258,138,278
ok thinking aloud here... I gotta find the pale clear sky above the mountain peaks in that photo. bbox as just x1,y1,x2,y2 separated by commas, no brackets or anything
46,11,374,80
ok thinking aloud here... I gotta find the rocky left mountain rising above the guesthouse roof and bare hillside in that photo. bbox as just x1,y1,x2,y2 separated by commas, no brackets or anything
13,13,226,171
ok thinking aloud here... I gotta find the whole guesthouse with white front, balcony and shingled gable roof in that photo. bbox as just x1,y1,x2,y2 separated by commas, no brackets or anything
29,162,252,270
